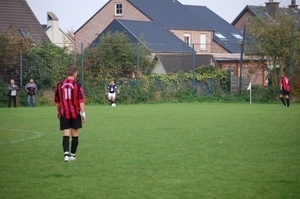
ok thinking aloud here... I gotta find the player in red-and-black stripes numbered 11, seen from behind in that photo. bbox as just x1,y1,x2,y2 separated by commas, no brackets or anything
55,66,86,162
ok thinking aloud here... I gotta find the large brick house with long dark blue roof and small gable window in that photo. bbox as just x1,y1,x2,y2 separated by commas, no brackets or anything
75,0,241,54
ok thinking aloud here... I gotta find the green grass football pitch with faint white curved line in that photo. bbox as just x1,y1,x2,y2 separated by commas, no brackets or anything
0,103,300,199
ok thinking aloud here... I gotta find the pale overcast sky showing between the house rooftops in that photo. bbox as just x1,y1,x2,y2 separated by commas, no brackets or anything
27,0,292,32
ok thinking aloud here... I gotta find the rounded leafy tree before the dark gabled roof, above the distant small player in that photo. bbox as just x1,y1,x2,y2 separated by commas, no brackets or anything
85,31,153,81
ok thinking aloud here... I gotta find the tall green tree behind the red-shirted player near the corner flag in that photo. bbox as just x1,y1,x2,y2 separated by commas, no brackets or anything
245,12,300,86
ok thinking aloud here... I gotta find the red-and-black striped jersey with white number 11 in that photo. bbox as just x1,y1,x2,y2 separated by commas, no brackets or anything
55,79,84,119
